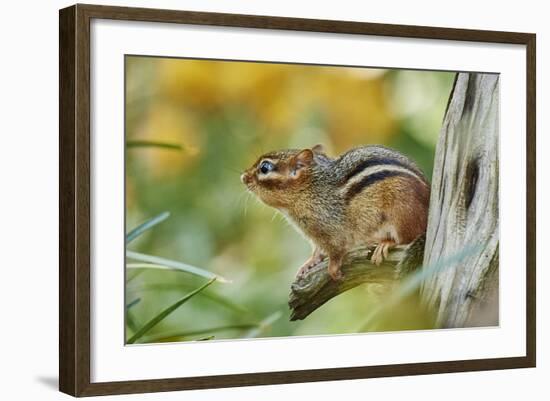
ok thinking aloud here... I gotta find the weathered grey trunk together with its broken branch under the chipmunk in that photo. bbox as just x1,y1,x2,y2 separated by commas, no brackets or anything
289,73,499,327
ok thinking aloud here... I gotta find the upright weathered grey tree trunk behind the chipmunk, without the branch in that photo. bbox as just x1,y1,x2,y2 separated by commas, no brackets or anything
422,73,499,327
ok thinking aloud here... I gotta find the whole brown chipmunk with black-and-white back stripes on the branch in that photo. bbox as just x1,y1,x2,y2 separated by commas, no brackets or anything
241,145,430,280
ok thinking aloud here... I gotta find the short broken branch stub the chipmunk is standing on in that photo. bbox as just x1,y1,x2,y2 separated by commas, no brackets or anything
288,236,425,320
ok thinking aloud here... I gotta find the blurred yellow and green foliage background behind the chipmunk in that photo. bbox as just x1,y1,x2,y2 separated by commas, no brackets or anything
126,56,455,343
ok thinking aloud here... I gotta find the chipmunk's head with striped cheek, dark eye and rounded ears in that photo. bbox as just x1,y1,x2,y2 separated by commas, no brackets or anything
241,145,326,208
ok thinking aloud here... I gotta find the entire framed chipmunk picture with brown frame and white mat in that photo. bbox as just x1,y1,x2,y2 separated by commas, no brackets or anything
59,5,536,396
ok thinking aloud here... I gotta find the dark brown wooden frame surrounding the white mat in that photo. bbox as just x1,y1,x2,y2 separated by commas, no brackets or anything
59,5,536,396
